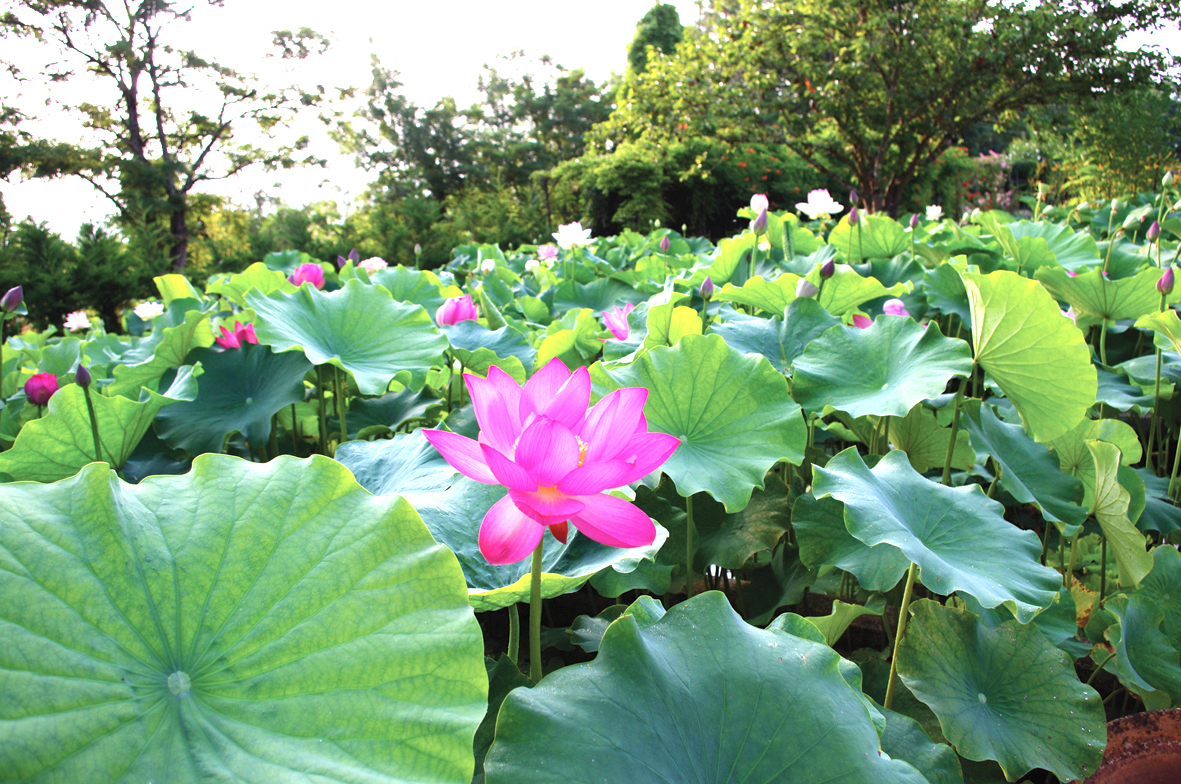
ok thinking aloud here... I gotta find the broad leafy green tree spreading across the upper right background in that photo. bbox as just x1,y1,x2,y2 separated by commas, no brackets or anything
595,0,1154,214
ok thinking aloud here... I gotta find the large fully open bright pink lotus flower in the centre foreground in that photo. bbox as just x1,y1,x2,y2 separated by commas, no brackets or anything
423,359,680,564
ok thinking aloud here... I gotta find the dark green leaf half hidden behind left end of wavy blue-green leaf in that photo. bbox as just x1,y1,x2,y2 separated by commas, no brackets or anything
791,495,911,593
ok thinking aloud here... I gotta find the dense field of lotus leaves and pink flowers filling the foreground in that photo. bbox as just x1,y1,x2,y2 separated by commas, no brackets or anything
0,189,1181,784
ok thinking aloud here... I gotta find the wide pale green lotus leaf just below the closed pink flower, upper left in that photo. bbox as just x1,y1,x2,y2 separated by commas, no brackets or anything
246,279,446,394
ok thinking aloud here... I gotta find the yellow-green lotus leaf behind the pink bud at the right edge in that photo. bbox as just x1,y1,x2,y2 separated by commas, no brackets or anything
1037,267,1181,322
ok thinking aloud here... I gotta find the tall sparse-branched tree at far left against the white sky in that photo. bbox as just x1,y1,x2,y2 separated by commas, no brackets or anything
0,0,324,270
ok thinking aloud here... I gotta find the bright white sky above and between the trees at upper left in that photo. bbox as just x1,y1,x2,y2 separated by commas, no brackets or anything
0,0,698,239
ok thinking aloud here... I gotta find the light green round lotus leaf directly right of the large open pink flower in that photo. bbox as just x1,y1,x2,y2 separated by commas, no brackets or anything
591,335,808,511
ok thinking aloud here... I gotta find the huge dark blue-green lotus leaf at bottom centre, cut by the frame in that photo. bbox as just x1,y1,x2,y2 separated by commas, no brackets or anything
484,592,926,784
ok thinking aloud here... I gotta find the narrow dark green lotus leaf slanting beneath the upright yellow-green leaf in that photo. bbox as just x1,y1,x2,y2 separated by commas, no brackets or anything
960,400,1087,535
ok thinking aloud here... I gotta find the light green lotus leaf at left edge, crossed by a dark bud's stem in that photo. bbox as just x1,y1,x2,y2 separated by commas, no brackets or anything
0,367,197,482
